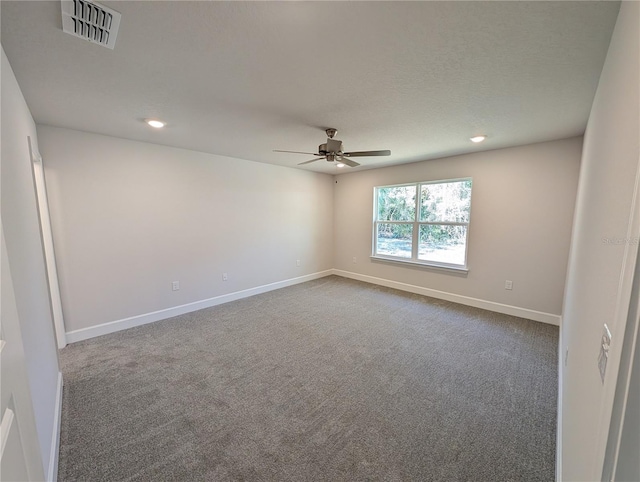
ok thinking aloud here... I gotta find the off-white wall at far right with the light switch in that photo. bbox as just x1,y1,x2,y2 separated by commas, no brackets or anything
560,2,640,481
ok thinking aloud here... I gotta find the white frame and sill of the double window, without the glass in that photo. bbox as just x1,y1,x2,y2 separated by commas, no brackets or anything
371,177,473,273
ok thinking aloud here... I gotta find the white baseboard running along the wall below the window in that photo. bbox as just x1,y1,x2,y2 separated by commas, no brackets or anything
333,269,560,326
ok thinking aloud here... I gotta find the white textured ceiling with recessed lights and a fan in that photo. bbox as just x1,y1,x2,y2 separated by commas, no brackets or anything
0,1,619,173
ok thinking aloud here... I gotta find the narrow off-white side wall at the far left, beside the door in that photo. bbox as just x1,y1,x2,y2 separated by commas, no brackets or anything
1,49,59,478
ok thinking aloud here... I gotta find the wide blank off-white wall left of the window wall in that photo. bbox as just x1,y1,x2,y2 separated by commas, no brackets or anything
38,126,333,332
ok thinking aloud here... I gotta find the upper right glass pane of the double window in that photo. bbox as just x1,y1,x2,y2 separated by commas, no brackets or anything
420,179,471,223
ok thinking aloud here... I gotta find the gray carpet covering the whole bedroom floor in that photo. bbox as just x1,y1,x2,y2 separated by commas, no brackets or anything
58,276,558,482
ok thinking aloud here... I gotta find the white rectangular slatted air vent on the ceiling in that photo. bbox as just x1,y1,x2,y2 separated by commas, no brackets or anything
62,0,121,49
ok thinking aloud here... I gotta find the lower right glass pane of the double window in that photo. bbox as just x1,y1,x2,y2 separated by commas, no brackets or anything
418,224,467,266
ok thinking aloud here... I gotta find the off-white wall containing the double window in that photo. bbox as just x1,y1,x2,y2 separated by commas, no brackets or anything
334,138,582,315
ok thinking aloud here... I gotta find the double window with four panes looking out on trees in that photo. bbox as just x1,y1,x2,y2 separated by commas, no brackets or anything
373,179,471,268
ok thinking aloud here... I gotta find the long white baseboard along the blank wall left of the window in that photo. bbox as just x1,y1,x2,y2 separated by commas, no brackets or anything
67,269,333,343
